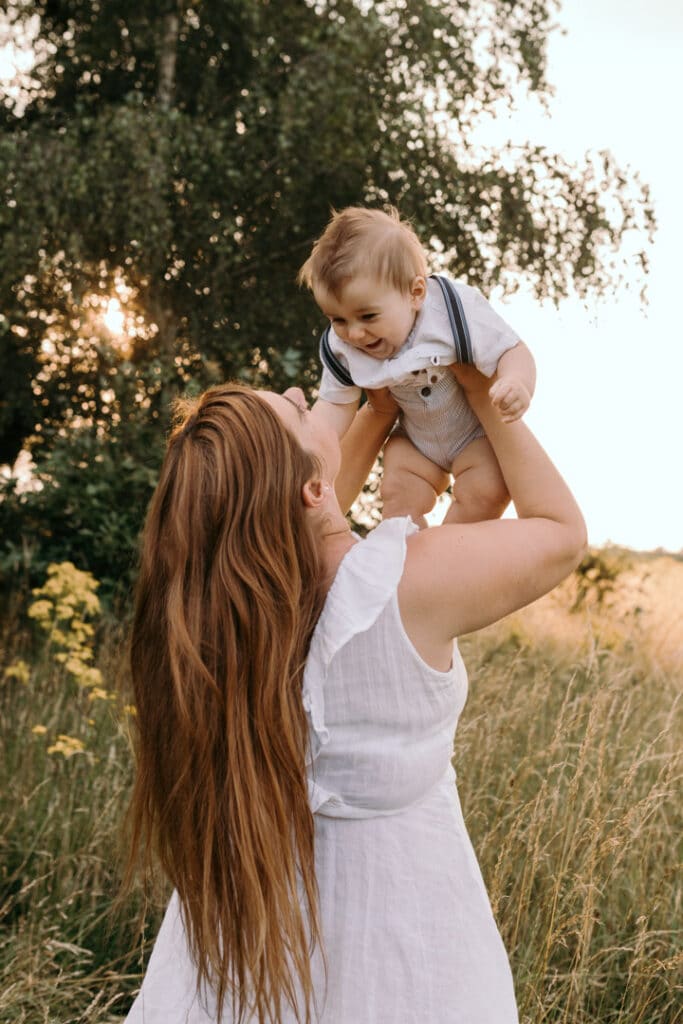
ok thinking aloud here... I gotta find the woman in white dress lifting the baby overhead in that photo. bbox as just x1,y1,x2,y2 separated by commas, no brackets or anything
121,367,585,1024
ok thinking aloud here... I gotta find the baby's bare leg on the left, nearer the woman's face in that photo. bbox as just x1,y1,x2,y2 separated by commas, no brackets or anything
381,434,451,529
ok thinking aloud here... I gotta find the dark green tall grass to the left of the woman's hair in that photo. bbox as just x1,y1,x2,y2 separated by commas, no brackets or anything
0,598,161,1024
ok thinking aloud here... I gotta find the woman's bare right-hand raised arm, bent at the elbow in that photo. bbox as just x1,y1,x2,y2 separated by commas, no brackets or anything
399,366,586,660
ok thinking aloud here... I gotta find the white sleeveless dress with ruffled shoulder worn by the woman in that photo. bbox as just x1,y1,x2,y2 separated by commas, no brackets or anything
127,519,518,1024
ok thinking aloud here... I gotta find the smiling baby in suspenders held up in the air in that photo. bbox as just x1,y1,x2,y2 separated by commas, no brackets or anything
299,207,536,526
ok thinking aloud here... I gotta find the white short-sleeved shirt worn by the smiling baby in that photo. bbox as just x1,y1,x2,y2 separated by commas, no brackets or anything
319,278,520,406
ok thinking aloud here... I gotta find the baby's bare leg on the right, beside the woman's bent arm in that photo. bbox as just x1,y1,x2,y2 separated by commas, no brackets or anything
443,437,510,522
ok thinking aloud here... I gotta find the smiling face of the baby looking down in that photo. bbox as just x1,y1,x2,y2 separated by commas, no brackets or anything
314,276,426,359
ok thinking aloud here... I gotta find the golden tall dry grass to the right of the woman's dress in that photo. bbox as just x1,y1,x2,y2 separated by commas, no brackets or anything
455,567,683,1024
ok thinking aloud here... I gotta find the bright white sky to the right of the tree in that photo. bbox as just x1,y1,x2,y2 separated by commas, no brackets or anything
0,0,683,551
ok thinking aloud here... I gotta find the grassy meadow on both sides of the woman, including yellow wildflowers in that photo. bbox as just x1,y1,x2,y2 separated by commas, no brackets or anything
0,553,683,1024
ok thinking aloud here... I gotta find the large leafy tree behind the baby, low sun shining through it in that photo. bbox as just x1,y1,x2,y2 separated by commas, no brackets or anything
0,0,653,598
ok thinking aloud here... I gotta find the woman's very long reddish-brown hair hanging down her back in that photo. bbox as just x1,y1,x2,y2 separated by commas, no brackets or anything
128,384,324,1024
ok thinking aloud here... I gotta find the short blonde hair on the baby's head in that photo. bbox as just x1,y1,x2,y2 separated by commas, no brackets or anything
297,206,427,299
